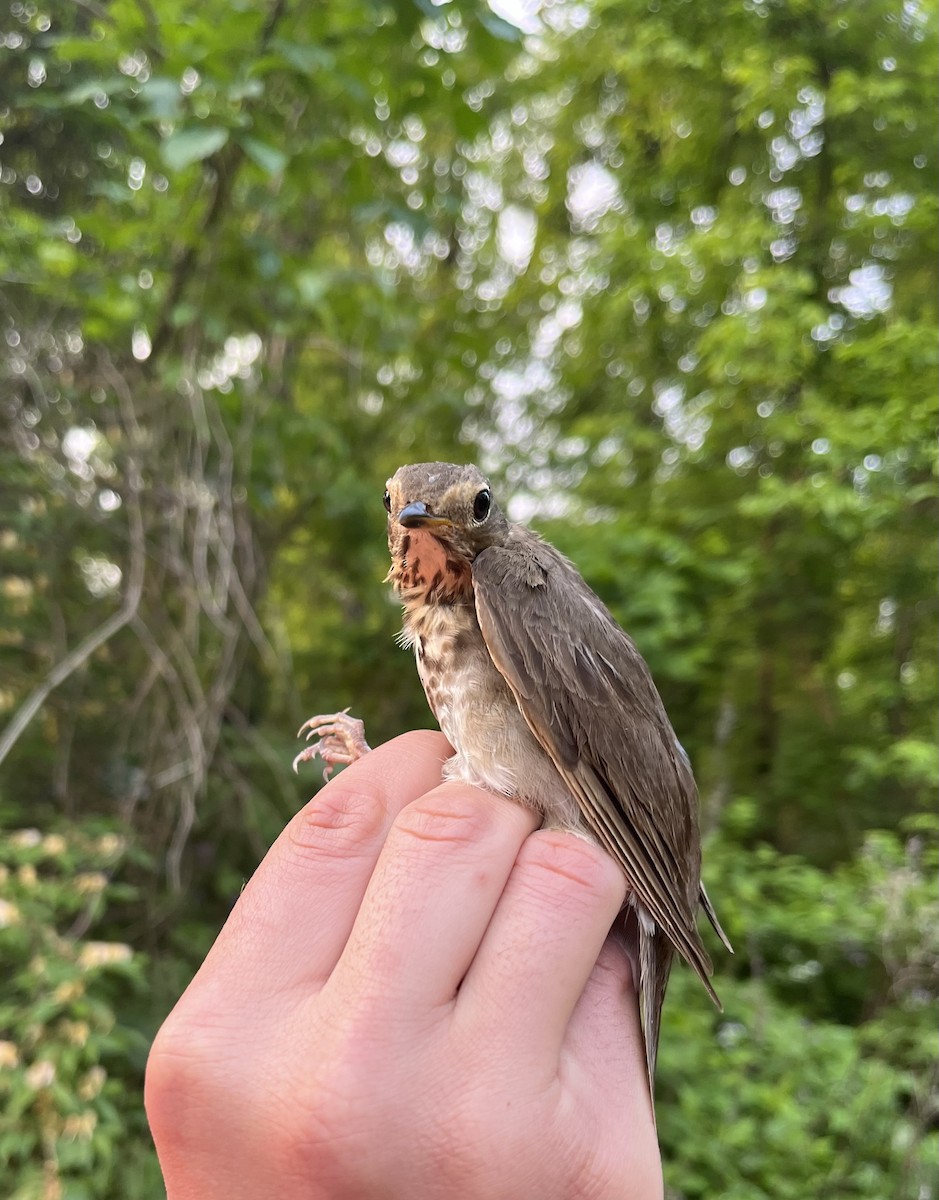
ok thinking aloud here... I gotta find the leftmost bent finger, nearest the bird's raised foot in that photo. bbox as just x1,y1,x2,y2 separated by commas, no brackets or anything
187,731,450,1009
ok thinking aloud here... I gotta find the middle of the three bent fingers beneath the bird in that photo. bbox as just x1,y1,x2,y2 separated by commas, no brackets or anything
329,782,538,1020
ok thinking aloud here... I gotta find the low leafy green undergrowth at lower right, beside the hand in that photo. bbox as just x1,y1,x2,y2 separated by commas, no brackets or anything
659,804,939,1200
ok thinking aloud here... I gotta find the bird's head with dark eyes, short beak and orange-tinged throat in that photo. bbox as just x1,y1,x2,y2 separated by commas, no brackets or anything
384,462,509,590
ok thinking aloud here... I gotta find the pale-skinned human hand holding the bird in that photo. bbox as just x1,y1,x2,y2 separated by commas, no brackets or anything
146,732,662,1200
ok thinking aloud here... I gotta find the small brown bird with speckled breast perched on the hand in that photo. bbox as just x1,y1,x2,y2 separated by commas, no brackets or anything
294,462,732,1096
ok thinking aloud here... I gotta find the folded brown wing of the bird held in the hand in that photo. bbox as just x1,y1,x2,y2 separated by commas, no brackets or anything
473,526,717,1002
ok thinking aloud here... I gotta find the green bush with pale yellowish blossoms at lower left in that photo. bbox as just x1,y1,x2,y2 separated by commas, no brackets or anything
0,822,160,1200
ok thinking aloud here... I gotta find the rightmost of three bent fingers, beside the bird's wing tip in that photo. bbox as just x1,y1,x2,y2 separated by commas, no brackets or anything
457,829,626,1073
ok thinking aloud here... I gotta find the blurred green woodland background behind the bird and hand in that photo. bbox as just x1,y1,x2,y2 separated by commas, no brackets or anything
0,0,939,1200
